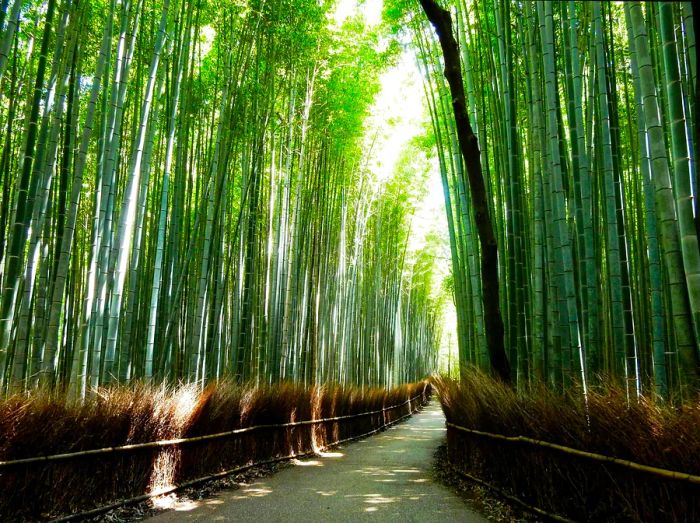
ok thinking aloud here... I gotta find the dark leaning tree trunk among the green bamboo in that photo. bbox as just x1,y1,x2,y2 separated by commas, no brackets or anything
420,0,511,383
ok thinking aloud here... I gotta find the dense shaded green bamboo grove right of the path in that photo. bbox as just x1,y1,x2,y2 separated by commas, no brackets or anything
387,0,700,398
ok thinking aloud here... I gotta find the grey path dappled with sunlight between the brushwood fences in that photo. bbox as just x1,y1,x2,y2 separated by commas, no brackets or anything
150,401,487,523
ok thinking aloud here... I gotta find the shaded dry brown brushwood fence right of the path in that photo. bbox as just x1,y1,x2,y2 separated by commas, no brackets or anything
433,372,700,522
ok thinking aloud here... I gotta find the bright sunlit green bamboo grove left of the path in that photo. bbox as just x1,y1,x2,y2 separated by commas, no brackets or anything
0,0,439,395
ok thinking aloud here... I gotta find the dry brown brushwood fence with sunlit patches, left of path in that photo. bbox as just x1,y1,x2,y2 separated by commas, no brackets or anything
0,383,430,521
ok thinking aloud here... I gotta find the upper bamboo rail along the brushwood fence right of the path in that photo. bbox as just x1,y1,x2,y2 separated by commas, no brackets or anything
448,421,700,485
